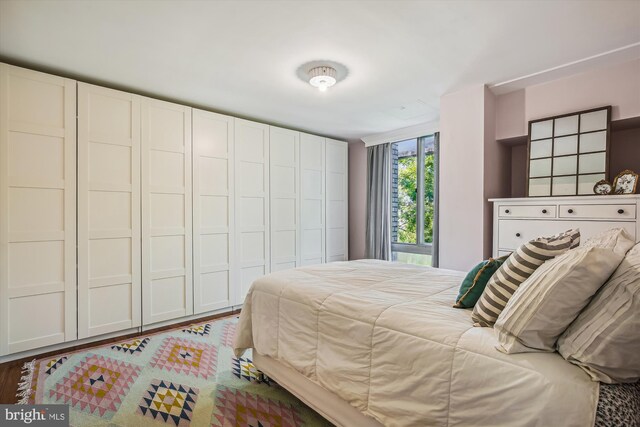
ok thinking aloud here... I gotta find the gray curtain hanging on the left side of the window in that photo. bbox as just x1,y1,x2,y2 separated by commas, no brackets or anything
365,144,391,260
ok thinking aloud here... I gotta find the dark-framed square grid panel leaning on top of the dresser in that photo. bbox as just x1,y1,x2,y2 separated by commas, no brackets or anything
527,106,611,197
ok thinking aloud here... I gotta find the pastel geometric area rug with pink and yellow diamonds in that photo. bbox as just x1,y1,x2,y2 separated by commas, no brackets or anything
20,317,331,427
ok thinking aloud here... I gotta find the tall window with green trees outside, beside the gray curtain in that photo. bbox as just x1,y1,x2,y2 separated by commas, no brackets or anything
391,135,437,265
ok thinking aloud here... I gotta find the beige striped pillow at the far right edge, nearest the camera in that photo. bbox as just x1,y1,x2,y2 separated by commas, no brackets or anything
558,243,640,383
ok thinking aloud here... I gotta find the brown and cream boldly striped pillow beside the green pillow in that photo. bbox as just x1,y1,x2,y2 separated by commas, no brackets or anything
471,229,580,327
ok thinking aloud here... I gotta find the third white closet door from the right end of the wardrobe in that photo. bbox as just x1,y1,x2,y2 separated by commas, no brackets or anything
269,126,300,271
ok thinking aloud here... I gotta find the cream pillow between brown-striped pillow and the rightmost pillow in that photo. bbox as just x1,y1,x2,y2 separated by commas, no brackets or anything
494,247,624,353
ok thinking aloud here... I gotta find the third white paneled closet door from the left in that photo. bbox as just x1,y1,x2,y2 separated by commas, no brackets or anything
142,98,193,325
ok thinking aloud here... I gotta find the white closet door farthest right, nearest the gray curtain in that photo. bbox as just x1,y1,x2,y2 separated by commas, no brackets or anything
326,139,349,262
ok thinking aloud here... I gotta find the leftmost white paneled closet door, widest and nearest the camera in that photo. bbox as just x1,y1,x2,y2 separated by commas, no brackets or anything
0,64,77,355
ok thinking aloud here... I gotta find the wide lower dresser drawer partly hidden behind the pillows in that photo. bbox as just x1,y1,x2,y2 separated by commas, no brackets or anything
498,219,637,251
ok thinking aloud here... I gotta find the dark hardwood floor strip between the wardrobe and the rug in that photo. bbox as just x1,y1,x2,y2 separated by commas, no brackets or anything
0,310,240,404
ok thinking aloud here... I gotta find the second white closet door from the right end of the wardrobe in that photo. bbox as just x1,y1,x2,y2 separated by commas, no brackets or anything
300,133,325,265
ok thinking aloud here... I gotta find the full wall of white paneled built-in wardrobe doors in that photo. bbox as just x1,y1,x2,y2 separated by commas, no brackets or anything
0,64,348,360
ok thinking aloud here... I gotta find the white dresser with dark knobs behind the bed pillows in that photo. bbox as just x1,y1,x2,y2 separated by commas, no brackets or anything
489,194,640,256
